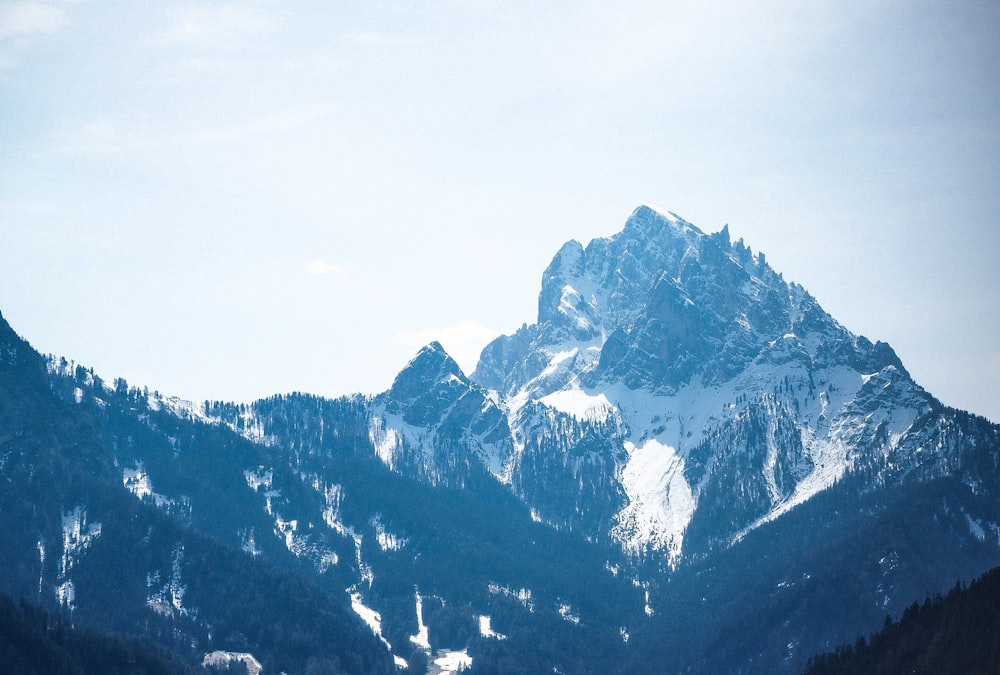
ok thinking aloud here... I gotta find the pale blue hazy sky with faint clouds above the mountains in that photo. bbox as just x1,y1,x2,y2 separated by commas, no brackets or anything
0,0,1000,421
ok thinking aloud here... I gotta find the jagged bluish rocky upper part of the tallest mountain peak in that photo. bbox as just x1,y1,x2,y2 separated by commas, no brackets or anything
474,205,908,396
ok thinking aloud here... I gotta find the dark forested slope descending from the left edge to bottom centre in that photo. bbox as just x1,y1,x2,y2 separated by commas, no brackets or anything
0,312,392,672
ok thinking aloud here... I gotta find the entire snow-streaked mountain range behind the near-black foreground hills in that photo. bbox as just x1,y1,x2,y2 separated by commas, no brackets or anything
0,207,1000,673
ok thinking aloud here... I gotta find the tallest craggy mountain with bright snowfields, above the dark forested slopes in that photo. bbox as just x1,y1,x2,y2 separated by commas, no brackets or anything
368,206,968,564
